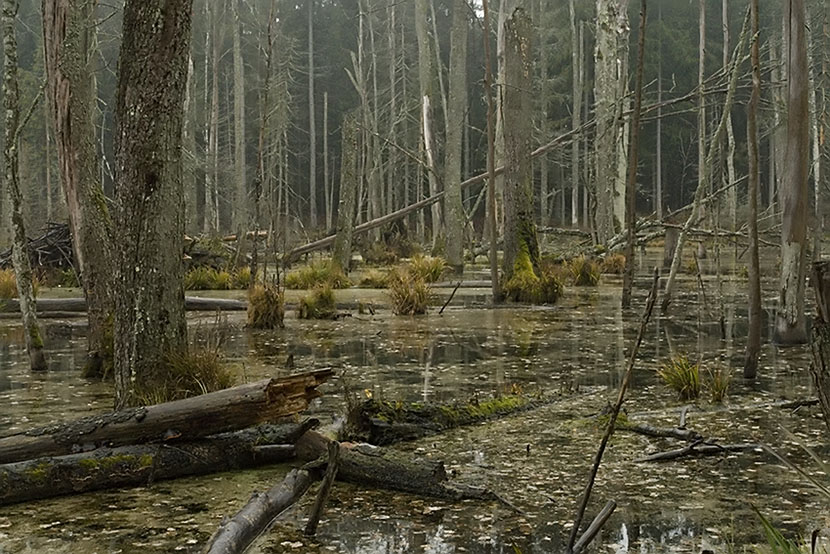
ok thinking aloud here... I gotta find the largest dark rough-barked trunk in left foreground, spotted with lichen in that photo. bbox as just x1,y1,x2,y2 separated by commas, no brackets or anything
114,0,192,408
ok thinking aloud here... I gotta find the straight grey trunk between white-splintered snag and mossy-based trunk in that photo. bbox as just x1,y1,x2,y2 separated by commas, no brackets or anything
444,2,468,274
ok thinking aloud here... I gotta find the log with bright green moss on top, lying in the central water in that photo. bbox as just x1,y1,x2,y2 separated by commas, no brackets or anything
345,394,559,445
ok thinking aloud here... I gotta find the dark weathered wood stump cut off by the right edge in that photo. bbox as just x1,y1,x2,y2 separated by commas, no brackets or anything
810,262,830,431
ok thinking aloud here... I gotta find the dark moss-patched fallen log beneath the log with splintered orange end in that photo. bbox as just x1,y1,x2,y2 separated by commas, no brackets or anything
0,420,316,505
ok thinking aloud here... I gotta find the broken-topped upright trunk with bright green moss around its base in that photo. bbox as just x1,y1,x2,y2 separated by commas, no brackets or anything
502,8,539,280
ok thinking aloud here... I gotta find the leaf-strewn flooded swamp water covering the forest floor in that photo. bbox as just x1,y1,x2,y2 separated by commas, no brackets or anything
0,248,830,553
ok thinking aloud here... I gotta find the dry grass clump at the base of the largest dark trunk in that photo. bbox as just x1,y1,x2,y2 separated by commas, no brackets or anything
136,348,236,405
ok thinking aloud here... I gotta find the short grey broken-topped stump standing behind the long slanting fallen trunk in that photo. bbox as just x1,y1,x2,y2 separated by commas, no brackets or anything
332,114,360,271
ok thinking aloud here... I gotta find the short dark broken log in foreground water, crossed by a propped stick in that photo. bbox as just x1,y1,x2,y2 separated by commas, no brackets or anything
295,431,498,500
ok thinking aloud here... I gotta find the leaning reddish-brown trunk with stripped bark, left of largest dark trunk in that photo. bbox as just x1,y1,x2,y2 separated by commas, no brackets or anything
43,0,114,375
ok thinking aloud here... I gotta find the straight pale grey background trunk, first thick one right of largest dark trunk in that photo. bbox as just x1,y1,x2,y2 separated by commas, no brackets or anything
231,0,248,229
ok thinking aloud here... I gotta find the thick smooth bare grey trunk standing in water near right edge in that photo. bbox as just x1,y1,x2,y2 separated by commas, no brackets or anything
775,0,810,344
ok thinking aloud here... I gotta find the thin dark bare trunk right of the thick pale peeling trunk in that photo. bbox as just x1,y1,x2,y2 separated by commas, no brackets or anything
622,0,646,308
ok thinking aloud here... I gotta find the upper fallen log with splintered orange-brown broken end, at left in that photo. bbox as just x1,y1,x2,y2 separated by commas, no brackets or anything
0,369,333,463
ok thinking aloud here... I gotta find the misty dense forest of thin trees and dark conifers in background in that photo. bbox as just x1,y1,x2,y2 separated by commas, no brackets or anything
2,0,827,246
